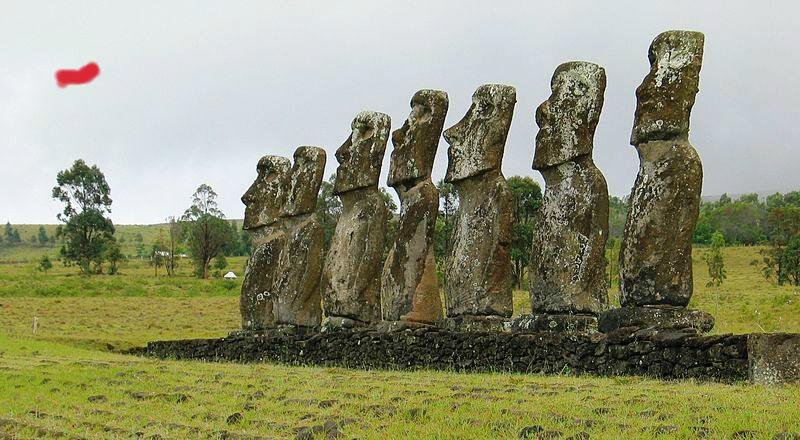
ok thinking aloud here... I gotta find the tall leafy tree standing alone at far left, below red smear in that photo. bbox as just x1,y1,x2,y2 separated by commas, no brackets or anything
52,159,114,275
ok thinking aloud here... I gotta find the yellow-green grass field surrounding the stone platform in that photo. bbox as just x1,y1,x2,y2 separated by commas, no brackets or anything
0,242,800,438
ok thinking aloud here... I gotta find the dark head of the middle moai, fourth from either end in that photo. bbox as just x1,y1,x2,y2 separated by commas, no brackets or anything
388,90,449,187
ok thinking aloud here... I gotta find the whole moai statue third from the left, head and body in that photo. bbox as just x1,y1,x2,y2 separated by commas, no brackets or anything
322,111,391,329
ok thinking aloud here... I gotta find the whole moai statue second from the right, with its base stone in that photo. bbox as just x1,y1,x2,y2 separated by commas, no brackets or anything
512,61,608,332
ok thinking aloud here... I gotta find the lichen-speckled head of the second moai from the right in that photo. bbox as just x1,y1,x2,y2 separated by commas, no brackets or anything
533,61,606,170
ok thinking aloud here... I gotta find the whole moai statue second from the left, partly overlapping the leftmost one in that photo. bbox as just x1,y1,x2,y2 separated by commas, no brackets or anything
273,147,325,329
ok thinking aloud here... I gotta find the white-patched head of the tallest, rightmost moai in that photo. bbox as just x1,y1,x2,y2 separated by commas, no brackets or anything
631,31,705,145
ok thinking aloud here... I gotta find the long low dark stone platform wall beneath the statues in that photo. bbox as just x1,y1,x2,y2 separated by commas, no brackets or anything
132,327,800,383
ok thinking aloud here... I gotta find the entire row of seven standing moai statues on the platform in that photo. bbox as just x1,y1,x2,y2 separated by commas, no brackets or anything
241,31,713,332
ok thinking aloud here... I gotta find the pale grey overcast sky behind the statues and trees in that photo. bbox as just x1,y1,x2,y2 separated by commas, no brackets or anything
0,0,800,224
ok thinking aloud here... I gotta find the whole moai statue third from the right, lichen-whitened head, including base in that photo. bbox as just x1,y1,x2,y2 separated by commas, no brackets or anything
443,84,517,331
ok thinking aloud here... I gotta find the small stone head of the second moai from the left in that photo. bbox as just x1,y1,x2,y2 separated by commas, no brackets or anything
281,147,326,217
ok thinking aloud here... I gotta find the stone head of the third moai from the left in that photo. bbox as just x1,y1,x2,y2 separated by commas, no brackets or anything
333,111,391,194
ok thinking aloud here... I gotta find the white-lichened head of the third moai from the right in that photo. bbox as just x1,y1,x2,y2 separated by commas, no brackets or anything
444,84,517,182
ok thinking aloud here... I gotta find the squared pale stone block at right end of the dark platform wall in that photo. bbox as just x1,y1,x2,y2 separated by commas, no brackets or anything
747,333,800,385
